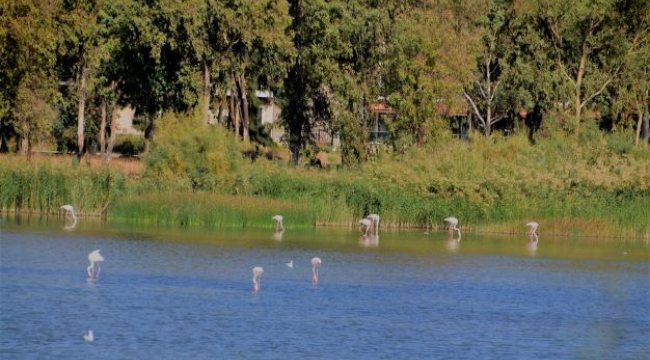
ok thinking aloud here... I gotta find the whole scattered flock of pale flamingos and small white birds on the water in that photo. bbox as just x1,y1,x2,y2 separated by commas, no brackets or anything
61,205,539,342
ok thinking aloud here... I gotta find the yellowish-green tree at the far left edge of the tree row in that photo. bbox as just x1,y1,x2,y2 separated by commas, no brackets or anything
0,0,59,156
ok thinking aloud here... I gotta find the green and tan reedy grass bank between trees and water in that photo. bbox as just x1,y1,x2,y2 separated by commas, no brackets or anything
0,119,650,239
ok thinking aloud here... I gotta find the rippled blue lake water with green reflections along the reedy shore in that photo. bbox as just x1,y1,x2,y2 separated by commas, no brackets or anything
0,218,650,359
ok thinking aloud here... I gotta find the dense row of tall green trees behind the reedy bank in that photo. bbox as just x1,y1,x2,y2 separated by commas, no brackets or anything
0,0,650,159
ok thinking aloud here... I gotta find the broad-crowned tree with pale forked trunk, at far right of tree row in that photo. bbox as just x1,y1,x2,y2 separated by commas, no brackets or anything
518,0,647,134
